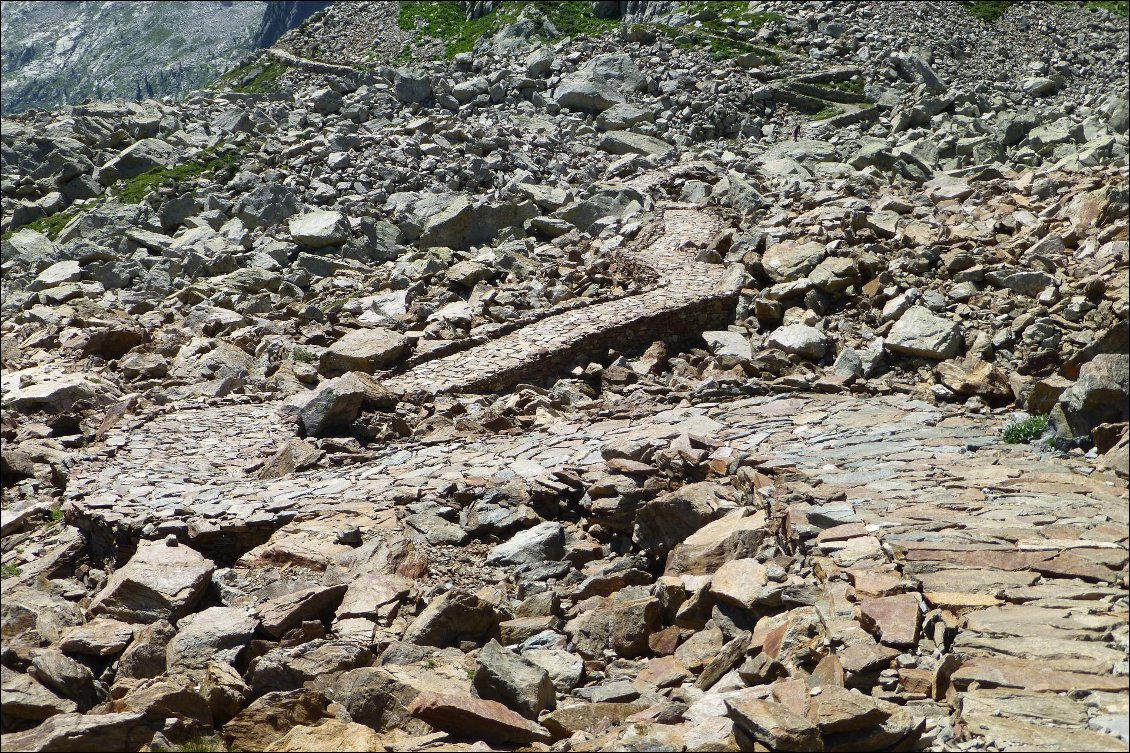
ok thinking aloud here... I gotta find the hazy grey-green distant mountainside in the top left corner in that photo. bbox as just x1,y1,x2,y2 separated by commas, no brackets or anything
0,0,329,115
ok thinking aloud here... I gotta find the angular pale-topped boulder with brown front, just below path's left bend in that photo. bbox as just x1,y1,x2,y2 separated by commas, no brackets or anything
90,539,216,624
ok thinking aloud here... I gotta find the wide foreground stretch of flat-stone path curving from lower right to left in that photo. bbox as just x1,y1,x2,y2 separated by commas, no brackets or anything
68,388,1130,750
